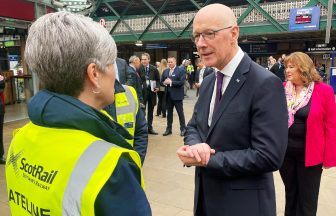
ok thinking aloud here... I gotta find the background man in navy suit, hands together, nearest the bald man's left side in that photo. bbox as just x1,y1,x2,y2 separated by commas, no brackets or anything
161,57,186,136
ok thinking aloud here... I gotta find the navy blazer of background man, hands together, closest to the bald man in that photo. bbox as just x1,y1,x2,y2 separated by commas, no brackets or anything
161,66,186,100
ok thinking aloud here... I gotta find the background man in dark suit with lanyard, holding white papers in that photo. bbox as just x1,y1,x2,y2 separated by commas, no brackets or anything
140,53,160,135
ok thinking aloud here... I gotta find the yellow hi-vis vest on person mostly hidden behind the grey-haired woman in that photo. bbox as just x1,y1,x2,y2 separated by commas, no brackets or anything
114,85,139,146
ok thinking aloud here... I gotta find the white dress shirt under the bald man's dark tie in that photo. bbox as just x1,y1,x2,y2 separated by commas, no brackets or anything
208,47,244,127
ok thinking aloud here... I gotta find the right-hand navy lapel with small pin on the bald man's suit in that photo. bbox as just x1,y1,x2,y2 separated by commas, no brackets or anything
208,54,251,136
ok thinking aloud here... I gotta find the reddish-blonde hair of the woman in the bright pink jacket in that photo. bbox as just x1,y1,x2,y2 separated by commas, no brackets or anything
284,52,322,86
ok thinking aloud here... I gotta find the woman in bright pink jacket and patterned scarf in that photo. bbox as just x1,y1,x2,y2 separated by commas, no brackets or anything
280,52,336,216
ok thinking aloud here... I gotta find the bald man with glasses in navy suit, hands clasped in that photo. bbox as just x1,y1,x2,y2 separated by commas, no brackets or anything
177,4,288,216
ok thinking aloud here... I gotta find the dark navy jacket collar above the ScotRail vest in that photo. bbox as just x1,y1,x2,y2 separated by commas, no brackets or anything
28,90,133,149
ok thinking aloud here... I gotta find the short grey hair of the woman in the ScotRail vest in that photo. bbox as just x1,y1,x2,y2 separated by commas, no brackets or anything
25,12,117,97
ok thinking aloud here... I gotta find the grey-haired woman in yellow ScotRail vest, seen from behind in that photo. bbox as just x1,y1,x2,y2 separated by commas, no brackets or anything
6,12,151,216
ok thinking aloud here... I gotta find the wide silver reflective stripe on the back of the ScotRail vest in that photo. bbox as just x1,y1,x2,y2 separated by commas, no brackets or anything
62,140,116,216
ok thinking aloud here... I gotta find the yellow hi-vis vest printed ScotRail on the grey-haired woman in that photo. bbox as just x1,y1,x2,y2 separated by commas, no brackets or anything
6,123,143,216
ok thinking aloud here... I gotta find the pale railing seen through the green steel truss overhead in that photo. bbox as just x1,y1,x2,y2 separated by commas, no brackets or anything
106,0,327,34
